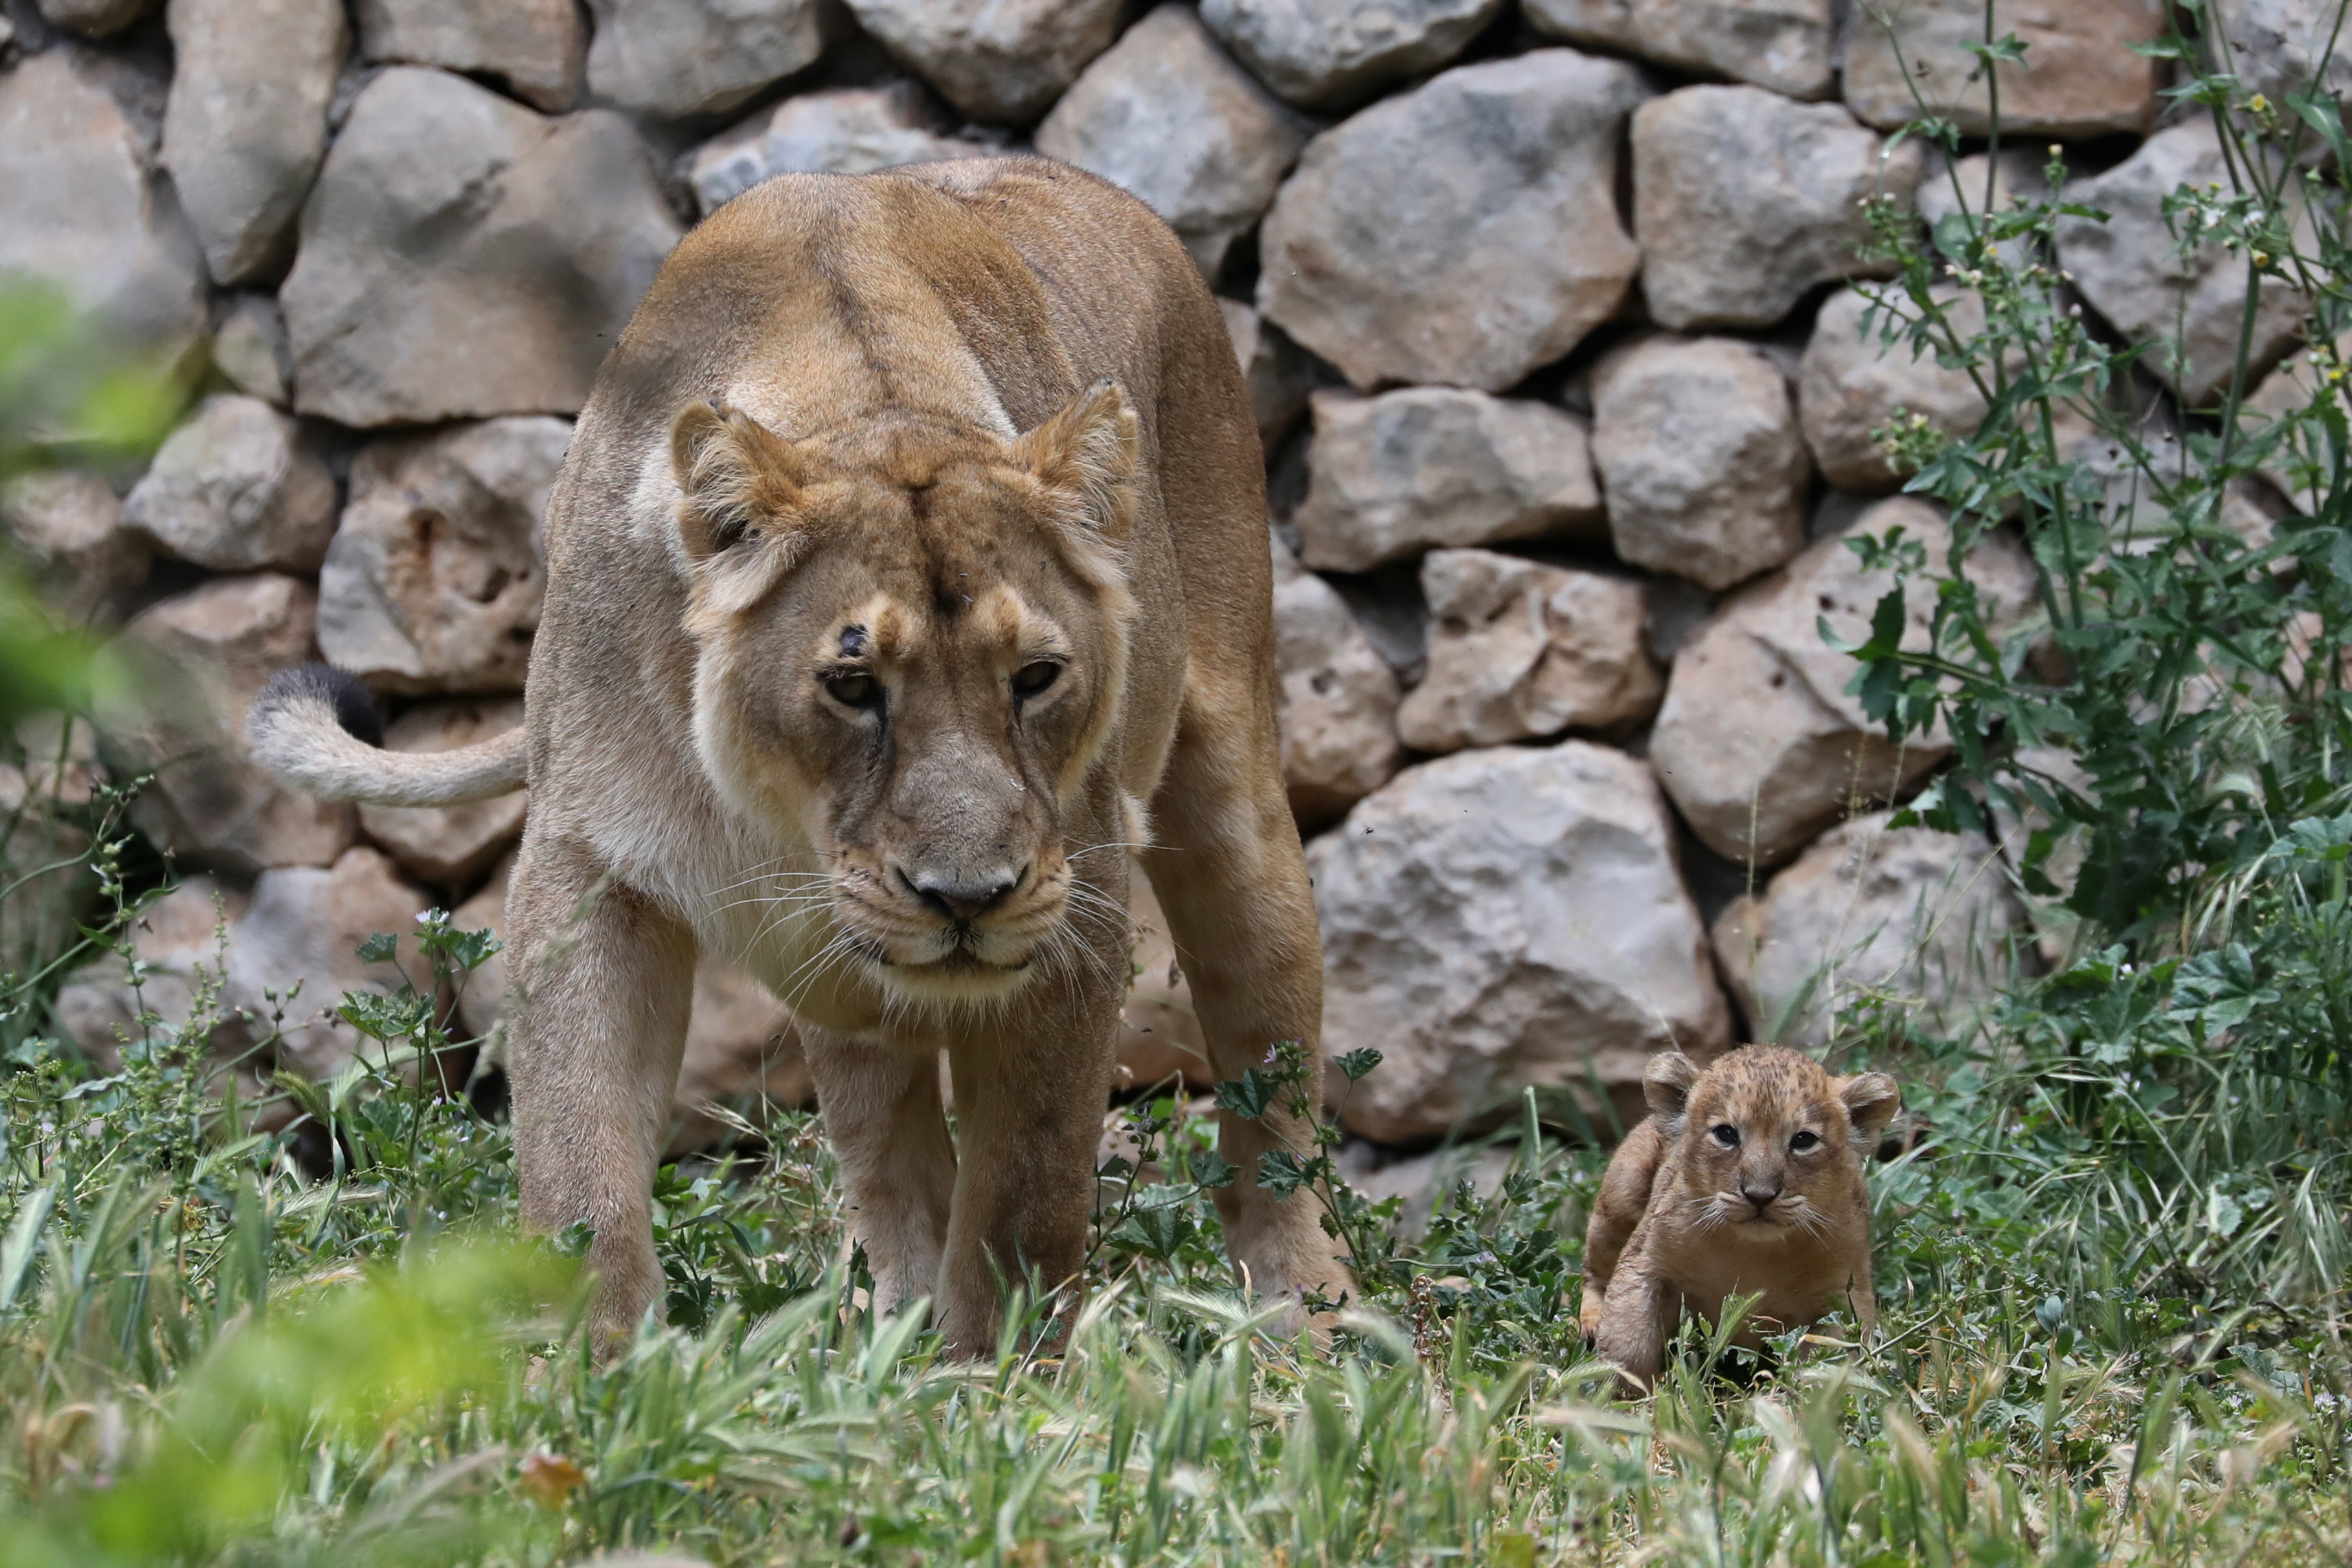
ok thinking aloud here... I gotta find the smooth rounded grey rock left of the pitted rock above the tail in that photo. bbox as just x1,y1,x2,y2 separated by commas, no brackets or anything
122,392,334,571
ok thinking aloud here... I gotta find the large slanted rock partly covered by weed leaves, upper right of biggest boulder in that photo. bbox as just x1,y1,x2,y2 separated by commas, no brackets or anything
1649,496,2035,865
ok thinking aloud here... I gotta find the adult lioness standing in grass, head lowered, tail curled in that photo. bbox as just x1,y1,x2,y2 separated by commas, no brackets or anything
252,160,1348,1354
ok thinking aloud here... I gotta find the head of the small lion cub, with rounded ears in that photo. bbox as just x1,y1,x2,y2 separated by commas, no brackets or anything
1642,1046,1903,1239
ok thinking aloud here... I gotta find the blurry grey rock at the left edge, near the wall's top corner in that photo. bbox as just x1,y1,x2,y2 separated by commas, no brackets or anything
0,49,205,341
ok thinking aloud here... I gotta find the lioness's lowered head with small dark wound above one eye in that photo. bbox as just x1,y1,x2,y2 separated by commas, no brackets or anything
670,381,1136,1002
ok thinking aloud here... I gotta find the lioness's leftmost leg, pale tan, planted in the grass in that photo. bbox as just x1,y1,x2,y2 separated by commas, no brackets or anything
506,832,694,1342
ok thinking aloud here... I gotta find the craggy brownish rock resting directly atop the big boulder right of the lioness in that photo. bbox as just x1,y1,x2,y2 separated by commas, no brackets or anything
1397,550,1665,752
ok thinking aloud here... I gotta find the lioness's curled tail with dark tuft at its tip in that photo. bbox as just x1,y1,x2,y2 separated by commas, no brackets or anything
245,666,527,806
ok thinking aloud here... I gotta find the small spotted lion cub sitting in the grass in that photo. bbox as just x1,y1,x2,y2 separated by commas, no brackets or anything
1581,1046,1903,1392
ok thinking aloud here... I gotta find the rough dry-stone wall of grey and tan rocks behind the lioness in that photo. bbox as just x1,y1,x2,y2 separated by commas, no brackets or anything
0,0,2333,1143
